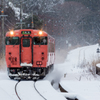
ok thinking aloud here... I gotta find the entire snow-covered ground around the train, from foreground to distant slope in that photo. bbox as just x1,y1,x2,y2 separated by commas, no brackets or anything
0,44,100,100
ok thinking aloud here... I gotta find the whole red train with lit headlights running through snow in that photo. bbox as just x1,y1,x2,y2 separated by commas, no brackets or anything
5,29,55,79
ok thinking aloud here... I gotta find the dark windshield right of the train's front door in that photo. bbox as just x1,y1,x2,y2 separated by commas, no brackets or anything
33,37,47,45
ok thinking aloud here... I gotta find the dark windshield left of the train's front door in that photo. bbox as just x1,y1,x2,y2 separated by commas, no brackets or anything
5,37,19,45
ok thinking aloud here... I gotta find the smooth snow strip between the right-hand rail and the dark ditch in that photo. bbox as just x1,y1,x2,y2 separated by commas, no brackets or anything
36,81,66,100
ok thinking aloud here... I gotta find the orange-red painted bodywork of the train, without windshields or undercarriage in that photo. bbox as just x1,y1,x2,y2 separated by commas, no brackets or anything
5,29,55,68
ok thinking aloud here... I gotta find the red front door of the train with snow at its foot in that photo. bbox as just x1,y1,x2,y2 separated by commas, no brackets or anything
20,37,32,66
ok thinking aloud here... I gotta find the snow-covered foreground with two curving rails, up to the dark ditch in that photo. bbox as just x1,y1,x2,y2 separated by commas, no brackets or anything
0,80,66,100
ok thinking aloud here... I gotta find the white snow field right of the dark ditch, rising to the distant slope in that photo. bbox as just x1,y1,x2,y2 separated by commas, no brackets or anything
60,44,100,100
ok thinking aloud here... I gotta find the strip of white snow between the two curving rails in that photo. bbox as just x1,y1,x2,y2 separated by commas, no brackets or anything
17,81,44,100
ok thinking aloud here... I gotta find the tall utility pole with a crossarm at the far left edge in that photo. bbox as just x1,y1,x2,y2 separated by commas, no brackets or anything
0,0,7,57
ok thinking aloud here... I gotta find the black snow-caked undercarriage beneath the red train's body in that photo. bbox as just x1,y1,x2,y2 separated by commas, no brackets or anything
7,65,53,80
